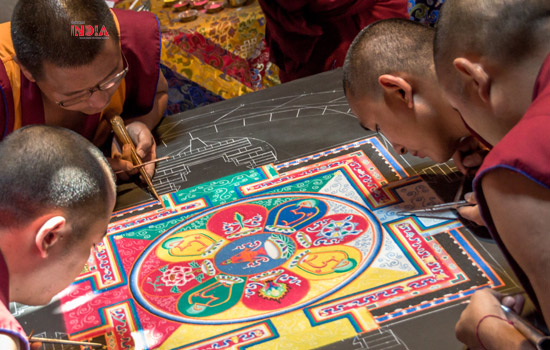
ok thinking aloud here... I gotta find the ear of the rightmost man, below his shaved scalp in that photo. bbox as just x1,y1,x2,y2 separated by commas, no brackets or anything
453,57,491,103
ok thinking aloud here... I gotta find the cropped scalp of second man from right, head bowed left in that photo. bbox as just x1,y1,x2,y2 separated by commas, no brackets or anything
344,19,435,99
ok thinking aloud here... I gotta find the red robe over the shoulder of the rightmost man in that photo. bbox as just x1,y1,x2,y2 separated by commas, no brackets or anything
474,54,550,306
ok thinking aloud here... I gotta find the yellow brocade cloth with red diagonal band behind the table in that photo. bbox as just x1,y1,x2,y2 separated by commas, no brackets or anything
157,0,280,99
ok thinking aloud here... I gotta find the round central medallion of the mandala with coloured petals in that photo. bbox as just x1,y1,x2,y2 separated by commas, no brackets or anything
130,193,383,324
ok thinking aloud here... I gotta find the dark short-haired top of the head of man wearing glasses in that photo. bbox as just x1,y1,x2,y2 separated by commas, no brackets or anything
11,0,119,79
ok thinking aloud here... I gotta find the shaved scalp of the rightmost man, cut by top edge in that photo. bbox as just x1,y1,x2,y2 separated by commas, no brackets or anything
434,0,550,92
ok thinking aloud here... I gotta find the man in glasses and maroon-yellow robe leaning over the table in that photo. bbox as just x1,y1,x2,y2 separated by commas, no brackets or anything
0,0,168,178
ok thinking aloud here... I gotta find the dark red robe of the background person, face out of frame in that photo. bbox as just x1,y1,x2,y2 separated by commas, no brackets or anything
259,0,409,82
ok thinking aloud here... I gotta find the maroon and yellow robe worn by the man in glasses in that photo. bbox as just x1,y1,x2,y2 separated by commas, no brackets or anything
0,9,161,146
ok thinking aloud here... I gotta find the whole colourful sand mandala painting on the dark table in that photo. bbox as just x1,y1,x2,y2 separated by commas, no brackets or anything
61,138,502,350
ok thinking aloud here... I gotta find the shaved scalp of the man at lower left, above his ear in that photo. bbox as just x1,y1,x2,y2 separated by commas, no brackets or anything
0,125,116,243
